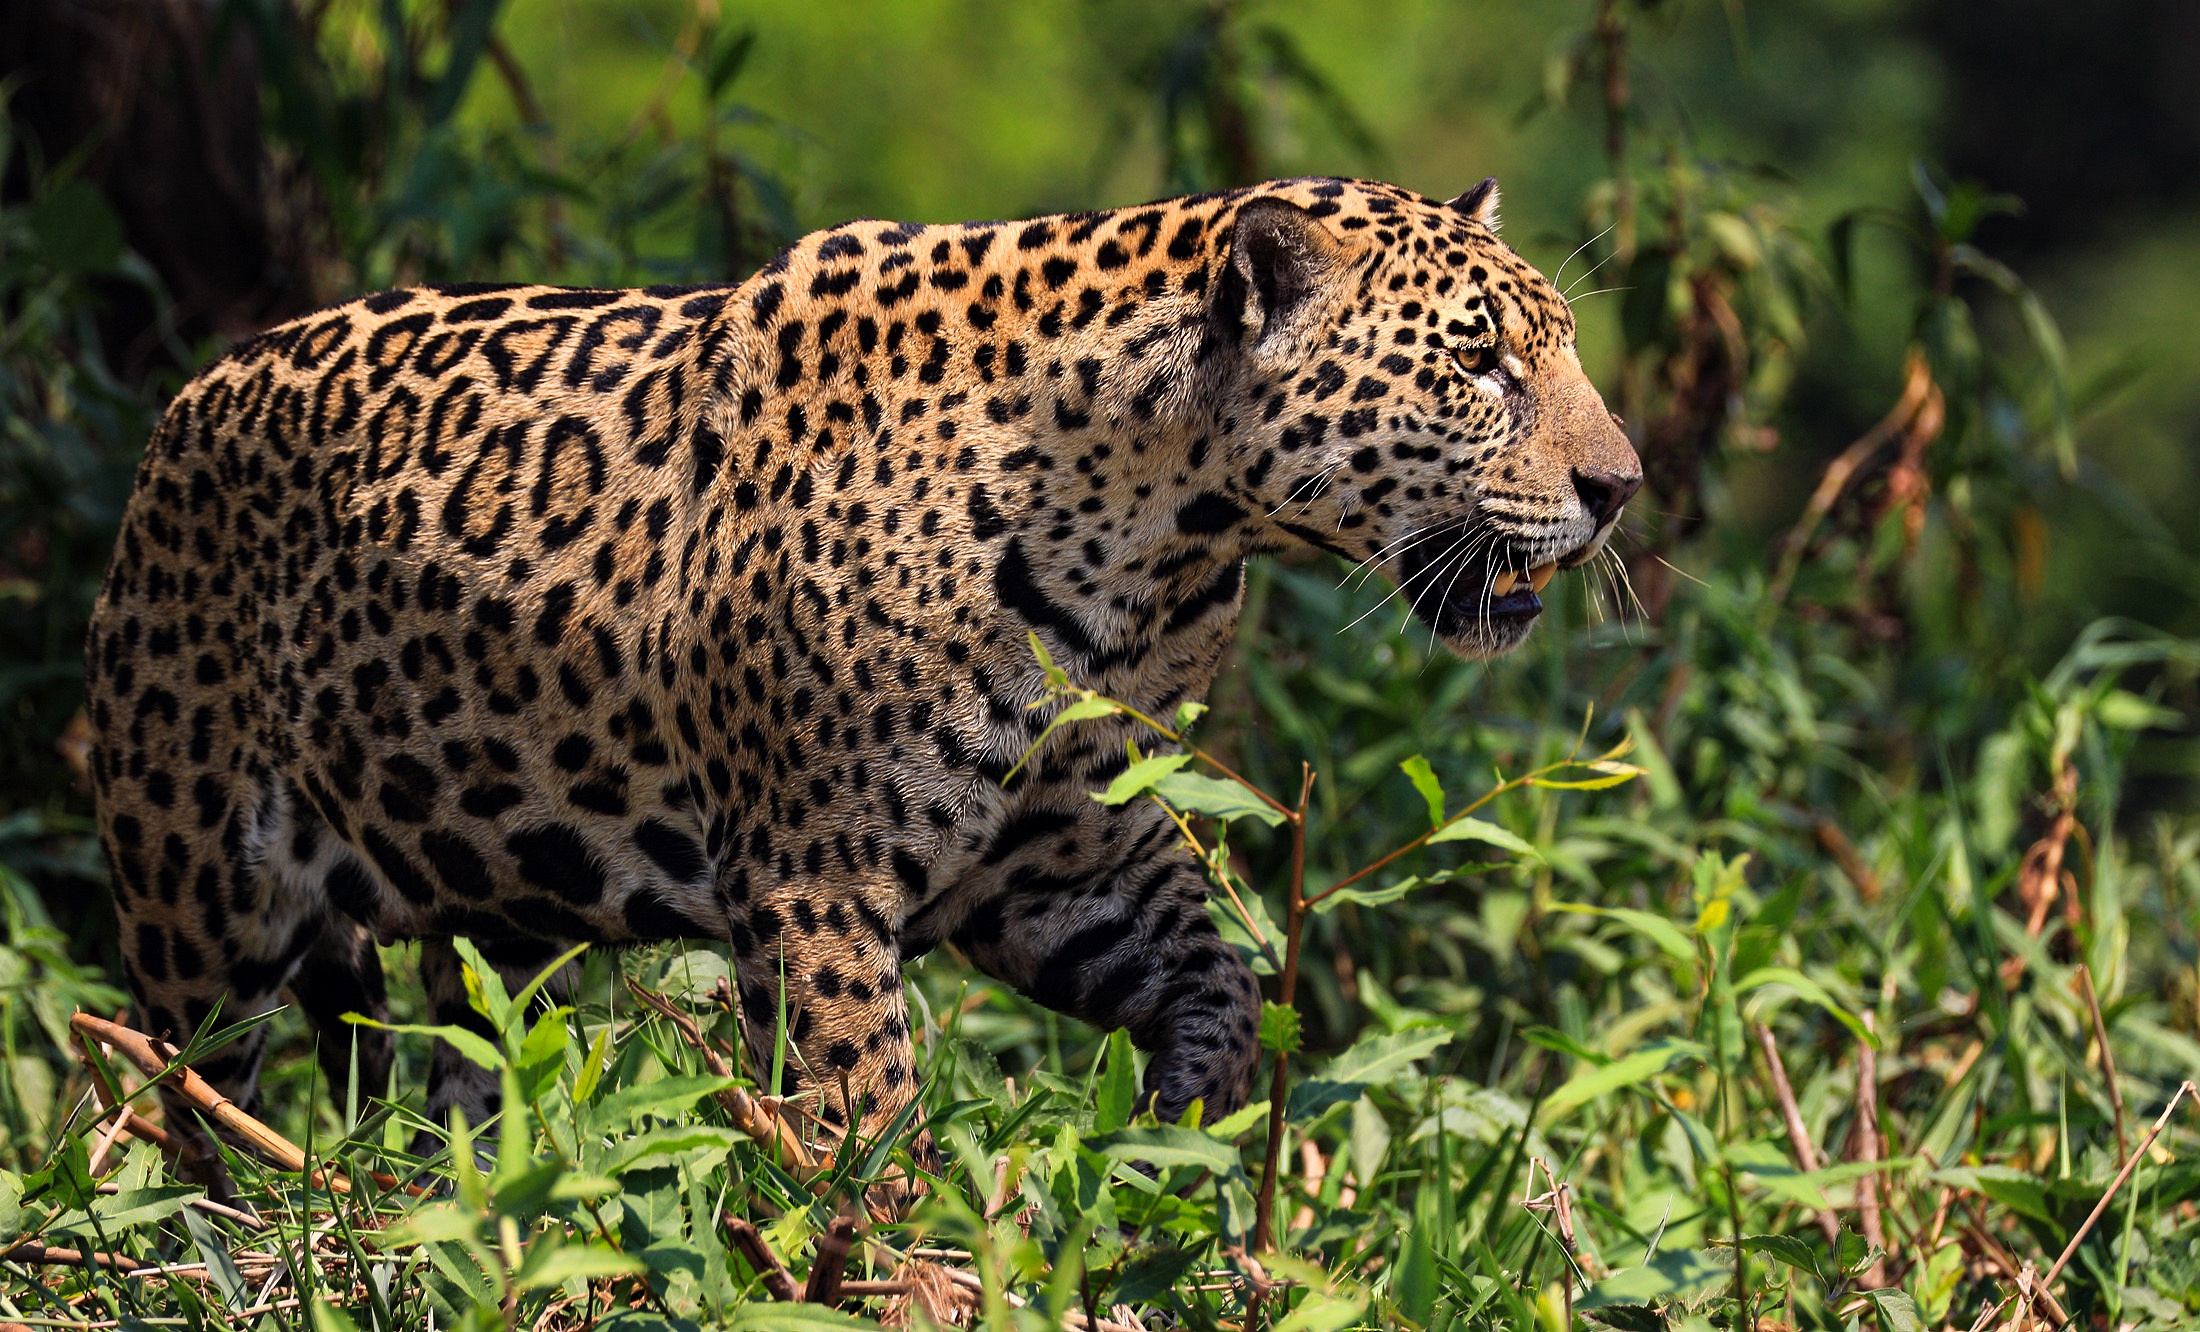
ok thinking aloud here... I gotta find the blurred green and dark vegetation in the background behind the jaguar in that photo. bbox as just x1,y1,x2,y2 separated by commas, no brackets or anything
0,0,2200,1308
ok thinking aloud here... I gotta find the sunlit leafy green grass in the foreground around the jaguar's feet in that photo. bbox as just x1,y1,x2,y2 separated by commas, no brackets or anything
0,598,2200,1332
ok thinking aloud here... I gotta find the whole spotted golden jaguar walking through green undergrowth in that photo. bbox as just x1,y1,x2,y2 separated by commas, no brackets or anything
88,181,1639,1153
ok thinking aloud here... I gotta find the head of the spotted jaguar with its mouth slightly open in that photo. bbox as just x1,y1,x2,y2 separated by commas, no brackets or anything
1223,181,1643,658
